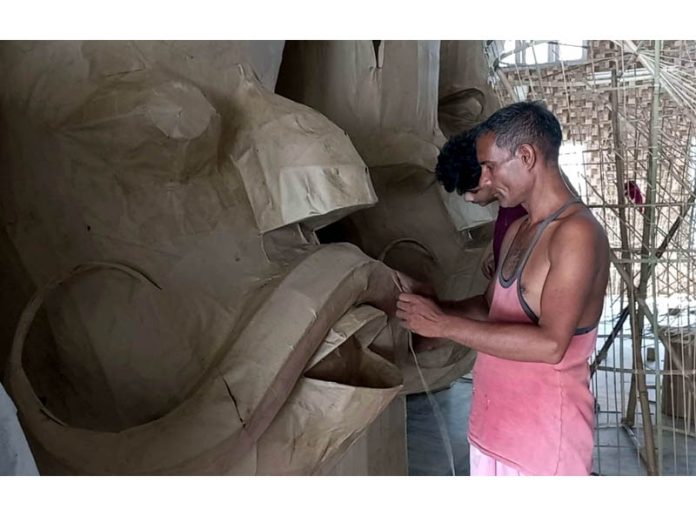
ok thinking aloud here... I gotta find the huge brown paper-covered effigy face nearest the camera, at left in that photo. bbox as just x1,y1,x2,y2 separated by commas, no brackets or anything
0,42,405,474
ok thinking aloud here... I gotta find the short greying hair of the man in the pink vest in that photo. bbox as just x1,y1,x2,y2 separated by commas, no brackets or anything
478,101,563,162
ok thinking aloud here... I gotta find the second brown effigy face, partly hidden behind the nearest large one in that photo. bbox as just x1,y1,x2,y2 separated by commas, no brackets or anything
277,41,496,392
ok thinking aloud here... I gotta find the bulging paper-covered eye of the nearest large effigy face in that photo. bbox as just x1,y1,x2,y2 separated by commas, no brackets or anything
61,72,221,182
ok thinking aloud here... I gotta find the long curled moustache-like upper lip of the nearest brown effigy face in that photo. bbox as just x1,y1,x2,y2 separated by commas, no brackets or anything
7,244,401,474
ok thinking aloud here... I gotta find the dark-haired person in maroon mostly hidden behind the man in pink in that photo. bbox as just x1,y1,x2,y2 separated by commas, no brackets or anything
435,128,527,279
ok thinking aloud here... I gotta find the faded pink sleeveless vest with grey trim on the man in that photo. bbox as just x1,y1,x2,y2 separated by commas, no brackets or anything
469,204,597,475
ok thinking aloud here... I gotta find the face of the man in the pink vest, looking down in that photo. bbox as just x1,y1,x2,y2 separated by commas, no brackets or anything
476,132,526,208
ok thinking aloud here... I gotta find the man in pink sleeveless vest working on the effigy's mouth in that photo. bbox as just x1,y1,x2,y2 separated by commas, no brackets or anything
397,102,609,475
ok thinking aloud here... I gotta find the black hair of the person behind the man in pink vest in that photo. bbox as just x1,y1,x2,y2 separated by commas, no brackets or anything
435,129,481,194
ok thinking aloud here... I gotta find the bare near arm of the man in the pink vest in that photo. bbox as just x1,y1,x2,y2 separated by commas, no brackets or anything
397,217,600,364
